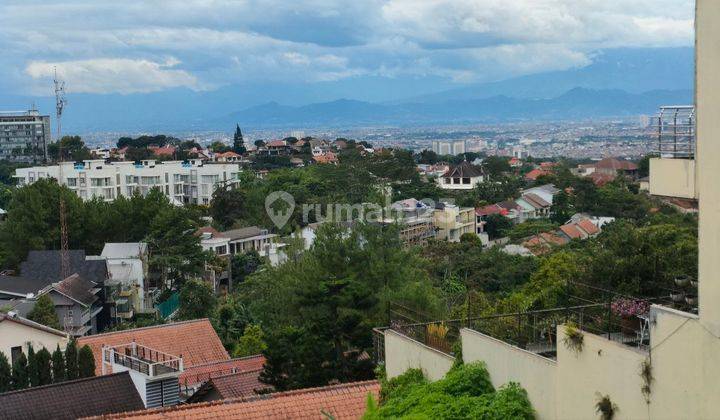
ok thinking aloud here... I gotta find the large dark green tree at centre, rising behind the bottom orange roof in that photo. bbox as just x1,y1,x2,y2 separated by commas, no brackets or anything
246,223,440,389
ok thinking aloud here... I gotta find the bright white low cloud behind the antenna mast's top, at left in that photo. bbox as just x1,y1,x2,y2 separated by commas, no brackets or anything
25,57,199,93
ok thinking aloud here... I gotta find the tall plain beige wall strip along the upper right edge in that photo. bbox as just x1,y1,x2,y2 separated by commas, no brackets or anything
695,0,720,337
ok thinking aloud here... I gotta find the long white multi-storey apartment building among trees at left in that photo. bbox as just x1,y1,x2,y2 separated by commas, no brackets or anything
14,159,240,204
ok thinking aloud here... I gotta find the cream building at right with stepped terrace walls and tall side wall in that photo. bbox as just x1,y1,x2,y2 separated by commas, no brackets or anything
377,4,720,419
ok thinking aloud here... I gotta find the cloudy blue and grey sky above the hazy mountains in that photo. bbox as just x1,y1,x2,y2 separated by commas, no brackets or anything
0,0,694,94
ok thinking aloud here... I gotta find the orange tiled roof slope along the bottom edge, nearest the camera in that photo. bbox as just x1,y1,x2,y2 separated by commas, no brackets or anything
95,381,380,420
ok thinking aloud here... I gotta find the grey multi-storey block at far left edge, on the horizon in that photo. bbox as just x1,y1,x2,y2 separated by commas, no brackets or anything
0,109,50,163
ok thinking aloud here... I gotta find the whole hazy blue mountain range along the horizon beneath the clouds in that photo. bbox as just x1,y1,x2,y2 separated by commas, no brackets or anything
0,48,694,133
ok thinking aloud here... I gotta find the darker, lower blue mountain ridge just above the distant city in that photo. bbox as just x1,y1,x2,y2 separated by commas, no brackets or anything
221,88,693,127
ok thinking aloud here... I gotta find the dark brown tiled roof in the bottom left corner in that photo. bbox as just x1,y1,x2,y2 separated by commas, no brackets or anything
0,372,145,420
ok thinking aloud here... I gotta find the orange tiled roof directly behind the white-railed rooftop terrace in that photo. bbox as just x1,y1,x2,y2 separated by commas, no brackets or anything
78,318,230,375
